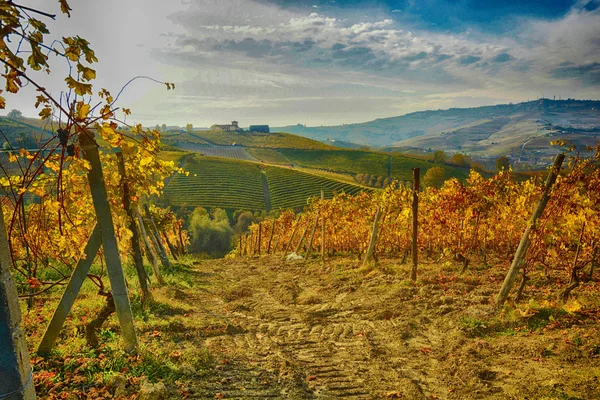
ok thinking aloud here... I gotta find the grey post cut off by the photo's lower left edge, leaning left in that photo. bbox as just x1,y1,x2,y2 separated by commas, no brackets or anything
0,202,35,400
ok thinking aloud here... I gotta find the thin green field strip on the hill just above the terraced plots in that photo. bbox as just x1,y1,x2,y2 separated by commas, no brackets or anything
278,149,469,180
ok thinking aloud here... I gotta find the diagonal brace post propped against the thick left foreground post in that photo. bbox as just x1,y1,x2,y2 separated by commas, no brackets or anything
38,224,102,354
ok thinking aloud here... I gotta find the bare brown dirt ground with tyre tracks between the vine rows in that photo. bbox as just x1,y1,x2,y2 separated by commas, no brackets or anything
177,257,600,399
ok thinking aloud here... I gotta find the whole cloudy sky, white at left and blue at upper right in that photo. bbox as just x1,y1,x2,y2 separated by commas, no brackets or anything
7,0,600,127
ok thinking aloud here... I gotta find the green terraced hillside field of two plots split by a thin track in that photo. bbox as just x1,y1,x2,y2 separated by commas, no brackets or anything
165,155,365,210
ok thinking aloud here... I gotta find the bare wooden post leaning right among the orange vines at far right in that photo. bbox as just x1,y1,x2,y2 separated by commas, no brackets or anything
496,153,565,308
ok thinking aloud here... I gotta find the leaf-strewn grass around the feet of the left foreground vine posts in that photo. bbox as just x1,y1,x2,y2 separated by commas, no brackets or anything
26,259,215,399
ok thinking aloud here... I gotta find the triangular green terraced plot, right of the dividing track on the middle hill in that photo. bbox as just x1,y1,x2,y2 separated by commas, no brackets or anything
265,166,364,208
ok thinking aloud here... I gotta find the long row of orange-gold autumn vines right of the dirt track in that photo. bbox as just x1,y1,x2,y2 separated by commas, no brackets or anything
243,149,600,304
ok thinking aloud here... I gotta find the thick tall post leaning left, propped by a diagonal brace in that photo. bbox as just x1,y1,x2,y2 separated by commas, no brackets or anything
79,131,137,353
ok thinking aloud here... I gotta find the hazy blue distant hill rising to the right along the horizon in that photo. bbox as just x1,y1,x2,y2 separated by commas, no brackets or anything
273,99,600,164
